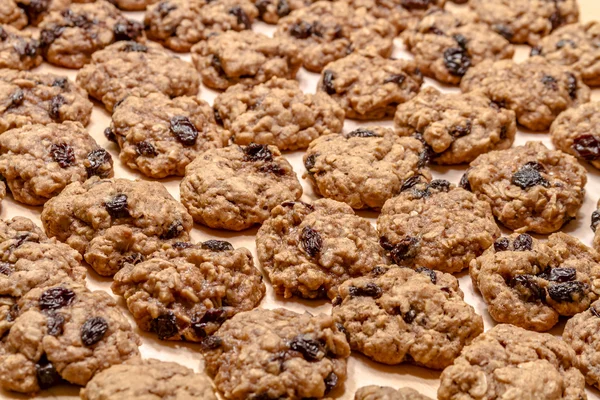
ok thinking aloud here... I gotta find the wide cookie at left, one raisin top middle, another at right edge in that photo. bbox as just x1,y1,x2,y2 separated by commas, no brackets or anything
41,177,193,276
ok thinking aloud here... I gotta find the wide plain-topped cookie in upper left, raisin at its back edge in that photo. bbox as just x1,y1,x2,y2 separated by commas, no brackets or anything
77,41,200,111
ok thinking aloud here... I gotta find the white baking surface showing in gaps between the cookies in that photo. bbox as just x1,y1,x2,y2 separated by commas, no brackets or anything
0,0,600,400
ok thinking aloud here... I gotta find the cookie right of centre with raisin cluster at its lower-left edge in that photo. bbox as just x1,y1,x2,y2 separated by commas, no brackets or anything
377,179,500,273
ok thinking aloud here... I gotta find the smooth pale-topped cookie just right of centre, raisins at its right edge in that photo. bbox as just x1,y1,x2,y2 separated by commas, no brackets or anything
303,127,431,209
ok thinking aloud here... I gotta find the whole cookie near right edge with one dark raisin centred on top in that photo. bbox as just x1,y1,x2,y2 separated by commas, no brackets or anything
461,142,587,234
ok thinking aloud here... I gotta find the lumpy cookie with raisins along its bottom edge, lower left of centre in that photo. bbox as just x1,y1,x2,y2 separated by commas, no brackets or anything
111,240,266,342
